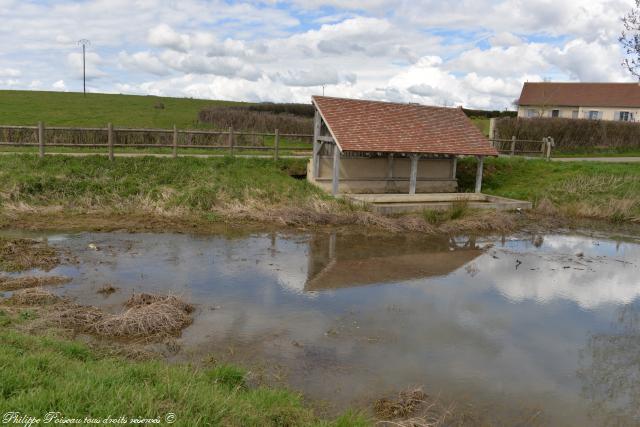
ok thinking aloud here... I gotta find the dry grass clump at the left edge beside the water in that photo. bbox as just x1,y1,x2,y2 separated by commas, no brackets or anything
0,238,60,271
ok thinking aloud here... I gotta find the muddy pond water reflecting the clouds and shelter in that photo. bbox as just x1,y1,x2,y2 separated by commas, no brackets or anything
3,233,640,425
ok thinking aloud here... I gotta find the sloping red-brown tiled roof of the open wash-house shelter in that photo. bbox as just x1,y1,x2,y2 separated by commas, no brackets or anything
312,96,498,156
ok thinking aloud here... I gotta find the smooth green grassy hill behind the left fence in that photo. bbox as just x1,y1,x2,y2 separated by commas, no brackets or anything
0,90,242,129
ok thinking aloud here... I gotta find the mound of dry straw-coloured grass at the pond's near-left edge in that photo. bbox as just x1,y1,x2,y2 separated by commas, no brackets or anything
57,294,194,338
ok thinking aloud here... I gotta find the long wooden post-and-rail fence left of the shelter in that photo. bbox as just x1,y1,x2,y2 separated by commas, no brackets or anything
0,122,313,160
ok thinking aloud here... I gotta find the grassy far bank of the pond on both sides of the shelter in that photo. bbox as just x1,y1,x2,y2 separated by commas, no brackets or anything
0,154,640,233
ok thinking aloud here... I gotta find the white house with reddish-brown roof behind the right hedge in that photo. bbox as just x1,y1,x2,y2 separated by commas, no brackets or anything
518,82,640,122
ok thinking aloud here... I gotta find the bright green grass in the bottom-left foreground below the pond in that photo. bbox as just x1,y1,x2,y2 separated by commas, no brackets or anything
0,328,367,426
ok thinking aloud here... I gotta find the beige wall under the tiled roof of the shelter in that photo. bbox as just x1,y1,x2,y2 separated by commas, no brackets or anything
307,156,458,193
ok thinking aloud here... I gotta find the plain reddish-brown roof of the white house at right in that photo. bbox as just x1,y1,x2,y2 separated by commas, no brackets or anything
518,82,640,108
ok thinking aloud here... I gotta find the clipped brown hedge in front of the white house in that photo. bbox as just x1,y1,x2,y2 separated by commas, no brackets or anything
496,117,640,151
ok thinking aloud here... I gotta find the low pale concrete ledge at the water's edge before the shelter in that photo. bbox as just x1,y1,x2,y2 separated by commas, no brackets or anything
341,193,532,215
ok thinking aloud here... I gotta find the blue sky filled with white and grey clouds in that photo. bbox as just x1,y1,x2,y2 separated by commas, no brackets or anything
0,0,634,110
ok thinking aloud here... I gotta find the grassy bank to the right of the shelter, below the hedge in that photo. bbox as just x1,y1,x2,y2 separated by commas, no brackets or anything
458,158,640,222
